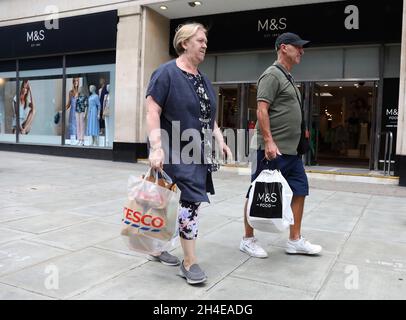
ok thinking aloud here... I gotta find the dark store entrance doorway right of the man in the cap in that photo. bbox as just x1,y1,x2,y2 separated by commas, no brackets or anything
310,81,377,168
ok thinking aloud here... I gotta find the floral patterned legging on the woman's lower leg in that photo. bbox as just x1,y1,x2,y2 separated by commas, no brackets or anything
178,200,200,240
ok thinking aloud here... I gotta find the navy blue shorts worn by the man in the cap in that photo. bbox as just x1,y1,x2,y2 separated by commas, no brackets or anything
247,150,309,198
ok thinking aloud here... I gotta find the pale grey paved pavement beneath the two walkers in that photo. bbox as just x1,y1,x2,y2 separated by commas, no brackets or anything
0,152,406,300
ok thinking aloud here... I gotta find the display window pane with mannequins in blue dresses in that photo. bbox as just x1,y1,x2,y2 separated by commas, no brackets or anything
65,65,114,148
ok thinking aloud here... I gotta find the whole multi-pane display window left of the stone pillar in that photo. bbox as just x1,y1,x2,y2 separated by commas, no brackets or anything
0,64,115,148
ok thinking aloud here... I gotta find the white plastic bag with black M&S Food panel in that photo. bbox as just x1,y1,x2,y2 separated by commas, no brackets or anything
247,170,294,232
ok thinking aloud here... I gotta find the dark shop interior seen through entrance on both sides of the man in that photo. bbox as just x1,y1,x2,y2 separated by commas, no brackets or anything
216,81,377,168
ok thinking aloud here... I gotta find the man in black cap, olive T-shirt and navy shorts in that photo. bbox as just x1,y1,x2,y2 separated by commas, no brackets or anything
240,33,322,258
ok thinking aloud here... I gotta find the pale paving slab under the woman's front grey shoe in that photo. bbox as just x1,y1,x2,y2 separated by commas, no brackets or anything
75,236,248,300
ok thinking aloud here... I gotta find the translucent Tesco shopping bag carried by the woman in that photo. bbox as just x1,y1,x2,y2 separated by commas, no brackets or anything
121,169,180,255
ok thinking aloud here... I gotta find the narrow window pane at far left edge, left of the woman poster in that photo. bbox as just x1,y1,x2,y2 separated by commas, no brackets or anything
0,72,16,142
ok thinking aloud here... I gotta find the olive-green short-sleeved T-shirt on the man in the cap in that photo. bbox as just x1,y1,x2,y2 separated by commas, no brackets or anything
251,62,302,155
